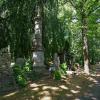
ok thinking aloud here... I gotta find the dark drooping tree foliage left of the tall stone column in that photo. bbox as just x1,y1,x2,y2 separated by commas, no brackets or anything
0,0,35,59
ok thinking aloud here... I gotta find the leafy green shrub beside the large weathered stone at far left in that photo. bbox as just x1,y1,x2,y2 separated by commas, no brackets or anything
13,61,32,87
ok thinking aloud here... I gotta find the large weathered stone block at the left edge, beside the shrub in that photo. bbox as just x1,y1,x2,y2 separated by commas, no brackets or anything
0,47,16,92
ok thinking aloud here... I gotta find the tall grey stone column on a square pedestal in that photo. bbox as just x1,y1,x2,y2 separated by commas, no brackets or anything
33,6,44,71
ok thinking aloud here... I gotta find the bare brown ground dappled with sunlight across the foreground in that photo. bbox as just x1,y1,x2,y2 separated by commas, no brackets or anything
0,75,100,100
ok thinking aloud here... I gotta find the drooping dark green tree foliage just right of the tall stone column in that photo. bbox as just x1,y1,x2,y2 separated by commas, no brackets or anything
43,0,70,60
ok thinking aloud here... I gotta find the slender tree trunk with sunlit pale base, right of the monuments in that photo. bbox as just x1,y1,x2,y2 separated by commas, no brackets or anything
81,16,89,74
